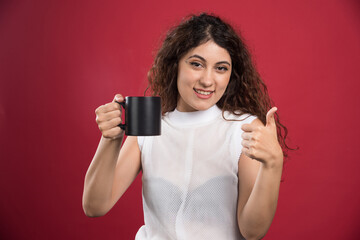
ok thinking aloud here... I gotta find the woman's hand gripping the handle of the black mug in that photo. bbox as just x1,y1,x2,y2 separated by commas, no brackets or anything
95,94,124,139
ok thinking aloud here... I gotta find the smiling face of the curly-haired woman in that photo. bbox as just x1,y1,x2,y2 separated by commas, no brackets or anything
176,41,231,112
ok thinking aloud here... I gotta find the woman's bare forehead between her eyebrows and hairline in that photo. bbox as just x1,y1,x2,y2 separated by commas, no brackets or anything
184,40,231,62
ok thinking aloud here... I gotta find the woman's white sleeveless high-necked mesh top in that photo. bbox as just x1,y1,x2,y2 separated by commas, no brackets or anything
135,105,255,240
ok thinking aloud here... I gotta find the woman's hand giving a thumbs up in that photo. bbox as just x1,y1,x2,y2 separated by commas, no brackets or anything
241,107,283,167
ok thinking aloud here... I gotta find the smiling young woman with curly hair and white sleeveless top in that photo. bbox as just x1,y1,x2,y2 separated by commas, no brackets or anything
83,14,287,240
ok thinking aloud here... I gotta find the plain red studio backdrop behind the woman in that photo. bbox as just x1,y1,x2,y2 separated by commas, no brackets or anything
0,0,360,240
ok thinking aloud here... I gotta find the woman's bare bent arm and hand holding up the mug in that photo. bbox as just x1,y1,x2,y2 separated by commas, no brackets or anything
83,97,141,217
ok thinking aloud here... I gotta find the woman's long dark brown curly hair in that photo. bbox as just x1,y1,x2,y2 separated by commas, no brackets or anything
147,13,291,157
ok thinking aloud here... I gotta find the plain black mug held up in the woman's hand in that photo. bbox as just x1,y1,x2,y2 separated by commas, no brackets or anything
117,97,161,136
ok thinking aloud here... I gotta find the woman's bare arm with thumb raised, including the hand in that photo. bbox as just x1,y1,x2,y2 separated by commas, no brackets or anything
237,109,283,239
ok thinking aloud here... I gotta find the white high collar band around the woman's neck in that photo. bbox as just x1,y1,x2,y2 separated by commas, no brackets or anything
168,105,222,126
